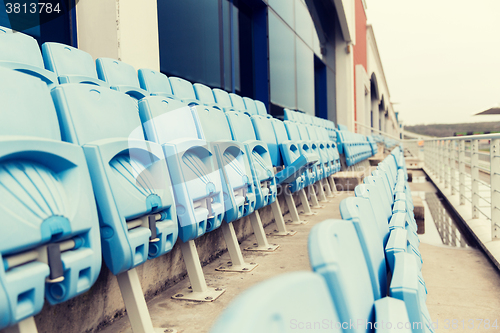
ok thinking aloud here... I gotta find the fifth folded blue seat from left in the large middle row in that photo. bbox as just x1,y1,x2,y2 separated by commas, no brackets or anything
226,111,277,209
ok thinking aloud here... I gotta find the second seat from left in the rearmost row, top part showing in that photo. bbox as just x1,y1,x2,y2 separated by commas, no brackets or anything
42,43,109,88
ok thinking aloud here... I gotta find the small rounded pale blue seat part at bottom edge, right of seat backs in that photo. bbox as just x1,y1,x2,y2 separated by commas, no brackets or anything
375,297,412,333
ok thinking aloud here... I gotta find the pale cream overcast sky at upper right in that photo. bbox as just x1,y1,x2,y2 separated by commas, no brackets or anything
366,0,500,124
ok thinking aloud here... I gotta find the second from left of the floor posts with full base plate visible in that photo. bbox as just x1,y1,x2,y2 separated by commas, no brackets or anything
216,222,258,272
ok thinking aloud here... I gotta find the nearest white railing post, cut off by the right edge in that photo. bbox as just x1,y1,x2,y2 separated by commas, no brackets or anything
490,139,500,240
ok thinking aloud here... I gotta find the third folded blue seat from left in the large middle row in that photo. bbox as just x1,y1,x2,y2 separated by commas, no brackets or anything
139,96,224,242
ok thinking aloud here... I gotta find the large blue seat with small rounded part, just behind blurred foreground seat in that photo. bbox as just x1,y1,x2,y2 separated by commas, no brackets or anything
308,220,412,333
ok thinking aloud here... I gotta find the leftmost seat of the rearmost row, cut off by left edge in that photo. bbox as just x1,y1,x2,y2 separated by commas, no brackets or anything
0,26,58,88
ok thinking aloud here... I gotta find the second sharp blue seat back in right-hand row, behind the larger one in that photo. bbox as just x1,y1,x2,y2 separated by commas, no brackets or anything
340,197,387,300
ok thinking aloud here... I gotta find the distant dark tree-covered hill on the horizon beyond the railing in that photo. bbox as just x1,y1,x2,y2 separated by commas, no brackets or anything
405,121,500,137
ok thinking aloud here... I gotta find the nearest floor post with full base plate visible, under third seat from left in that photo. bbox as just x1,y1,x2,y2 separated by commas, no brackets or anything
172,240,225,302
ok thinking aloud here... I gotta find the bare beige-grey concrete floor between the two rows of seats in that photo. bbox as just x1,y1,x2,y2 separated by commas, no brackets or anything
99,192,353,333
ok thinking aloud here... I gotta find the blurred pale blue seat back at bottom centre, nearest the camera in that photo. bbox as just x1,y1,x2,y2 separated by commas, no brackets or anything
210,272,344,333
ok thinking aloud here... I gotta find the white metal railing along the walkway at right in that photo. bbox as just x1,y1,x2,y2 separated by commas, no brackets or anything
416,134,500,240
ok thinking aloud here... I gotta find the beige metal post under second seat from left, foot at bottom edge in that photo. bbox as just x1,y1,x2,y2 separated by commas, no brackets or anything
116,268,178,333
